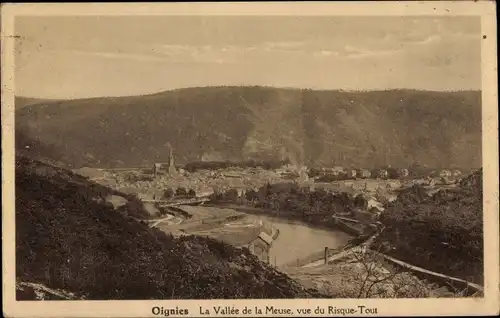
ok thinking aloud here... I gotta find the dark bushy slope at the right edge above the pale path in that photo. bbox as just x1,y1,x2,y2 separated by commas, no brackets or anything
380,169,484,284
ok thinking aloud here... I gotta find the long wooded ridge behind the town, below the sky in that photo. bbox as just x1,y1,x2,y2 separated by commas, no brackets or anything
16,87,481,168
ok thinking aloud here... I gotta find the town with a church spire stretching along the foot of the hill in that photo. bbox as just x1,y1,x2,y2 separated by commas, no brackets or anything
75,143,470,201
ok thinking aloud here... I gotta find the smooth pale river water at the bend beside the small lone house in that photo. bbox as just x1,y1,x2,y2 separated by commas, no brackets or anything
244,214,352,266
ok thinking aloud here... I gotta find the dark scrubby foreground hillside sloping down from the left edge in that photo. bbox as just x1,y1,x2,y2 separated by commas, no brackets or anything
16,156,320,300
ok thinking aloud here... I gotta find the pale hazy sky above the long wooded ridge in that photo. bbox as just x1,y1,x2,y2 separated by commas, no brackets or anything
15,16,481,98
